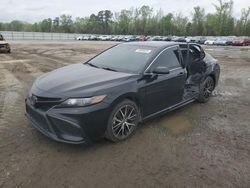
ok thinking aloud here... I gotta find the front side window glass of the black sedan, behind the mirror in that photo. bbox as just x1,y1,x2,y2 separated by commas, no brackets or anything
150,47,181,71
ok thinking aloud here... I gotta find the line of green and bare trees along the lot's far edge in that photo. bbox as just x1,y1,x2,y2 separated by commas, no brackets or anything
0,0,250,36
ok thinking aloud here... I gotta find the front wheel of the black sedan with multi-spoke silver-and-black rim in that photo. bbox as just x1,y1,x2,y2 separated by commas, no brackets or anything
105,99,140,142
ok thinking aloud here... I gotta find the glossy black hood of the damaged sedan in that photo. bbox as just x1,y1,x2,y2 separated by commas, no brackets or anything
33,64,136,98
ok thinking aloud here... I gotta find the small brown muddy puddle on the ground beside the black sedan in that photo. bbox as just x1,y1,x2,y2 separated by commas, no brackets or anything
159,115,193,135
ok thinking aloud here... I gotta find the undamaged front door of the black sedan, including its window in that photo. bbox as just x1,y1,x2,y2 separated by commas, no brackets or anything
144,46,187,116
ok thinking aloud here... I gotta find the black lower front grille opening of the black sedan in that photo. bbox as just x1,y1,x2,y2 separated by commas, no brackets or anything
26,105,50,132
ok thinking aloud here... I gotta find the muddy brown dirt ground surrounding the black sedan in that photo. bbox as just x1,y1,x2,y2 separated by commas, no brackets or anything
0,41,250,188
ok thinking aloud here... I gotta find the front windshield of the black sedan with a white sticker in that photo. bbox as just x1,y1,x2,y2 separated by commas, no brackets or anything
87,44,154,73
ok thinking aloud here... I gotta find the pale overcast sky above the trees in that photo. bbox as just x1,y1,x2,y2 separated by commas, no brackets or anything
0,0,250,23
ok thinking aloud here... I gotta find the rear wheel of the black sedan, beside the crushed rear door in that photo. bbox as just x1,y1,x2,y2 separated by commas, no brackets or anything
197,76,215,103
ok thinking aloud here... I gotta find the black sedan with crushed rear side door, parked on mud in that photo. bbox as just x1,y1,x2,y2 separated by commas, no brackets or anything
25,42,220,144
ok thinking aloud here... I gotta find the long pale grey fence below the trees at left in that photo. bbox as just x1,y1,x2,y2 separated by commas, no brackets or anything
0,31,86,40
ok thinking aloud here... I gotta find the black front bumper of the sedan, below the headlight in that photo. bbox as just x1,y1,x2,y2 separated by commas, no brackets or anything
25,99,109,144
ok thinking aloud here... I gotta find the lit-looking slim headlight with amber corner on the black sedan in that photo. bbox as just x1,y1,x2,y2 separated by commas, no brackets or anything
59,95,106,107
